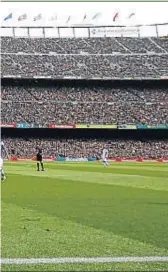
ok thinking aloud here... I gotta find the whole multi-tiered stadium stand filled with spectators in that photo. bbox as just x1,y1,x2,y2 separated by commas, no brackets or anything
1,32,168,159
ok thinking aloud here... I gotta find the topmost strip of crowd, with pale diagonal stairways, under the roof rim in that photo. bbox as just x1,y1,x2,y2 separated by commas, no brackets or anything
1,37,168,54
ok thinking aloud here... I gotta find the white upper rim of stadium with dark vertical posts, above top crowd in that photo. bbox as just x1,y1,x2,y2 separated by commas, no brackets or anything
1,22,168,38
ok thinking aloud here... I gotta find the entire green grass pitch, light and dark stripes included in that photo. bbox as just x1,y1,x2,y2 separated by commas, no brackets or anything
1,162,168,271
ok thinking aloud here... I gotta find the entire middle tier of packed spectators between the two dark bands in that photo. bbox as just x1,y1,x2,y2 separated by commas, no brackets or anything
1,86,168,126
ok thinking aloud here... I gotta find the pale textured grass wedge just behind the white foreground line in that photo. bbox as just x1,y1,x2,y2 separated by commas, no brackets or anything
1,202,168,258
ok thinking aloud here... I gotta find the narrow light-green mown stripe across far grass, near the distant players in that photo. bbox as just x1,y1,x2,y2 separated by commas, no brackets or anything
7,168,168,191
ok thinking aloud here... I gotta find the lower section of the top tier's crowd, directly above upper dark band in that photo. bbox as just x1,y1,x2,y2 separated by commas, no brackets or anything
1,53,168,79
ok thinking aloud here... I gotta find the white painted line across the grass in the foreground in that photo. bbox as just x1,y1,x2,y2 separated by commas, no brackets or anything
0,256,168,265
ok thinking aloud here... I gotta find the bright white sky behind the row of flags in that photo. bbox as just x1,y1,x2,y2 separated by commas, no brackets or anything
0,2,168,26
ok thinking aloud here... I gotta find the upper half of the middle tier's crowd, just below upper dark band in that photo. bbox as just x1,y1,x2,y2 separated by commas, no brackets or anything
1,84,168,103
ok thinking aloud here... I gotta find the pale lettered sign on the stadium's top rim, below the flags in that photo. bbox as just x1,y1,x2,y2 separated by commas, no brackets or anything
90,27,139,37
